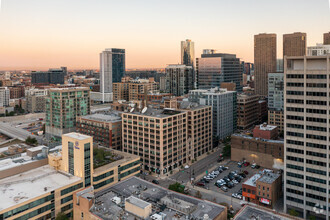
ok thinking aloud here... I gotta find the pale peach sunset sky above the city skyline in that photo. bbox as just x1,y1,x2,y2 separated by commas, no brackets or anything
0,0,330,70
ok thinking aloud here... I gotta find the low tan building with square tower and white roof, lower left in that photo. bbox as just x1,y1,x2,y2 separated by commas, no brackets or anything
0,133,140,219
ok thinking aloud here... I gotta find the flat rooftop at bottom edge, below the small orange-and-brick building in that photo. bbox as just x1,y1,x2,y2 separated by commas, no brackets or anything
233,205,298,220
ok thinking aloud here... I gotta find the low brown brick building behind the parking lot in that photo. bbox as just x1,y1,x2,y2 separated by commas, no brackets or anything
231,134,284,169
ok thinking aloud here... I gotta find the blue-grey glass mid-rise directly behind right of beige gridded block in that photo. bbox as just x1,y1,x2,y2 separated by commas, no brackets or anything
189,88,237,139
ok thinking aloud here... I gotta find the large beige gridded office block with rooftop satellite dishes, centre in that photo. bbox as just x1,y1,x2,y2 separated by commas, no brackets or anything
122,106,212,175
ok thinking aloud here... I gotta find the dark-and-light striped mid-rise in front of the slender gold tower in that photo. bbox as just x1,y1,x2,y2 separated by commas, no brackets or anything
165,65,194,96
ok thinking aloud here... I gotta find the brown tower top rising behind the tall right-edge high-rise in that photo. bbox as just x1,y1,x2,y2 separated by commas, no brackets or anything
283,32,307,58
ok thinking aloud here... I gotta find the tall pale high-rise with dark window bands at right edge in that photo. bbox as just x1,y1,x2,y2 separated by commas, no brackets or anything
283,55,330,219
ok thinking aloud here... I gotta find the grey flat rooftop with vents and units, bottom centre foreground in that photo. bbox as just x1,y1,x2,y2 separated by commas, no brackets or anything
90,176,226,220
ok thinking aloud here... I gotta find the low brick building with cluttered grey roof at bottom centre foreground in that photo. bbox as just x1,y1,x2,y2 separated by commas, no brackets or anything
73,177,227,220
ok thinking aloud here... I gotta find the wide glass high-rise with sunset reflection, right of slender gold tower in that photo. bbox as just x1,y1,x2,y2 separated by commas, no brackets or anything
196,50,243,92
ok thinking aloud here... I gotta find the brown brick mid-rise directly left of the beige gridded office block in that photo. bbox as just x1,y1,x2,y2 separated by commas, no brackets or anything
76,113,122,150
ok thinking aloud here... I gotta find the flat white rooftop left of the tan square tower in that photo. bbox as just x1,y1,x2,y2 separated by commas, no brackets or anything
0,165,81,211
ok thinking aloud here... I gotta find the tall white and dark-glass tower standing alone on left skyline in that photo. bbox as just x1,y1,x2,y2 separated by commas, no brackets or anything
100,48,125,102
